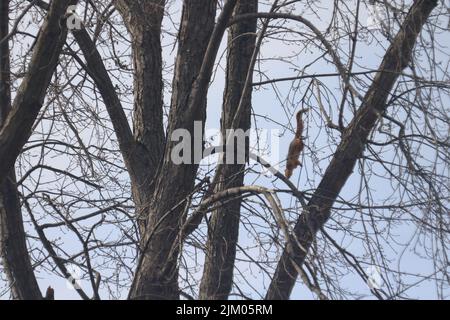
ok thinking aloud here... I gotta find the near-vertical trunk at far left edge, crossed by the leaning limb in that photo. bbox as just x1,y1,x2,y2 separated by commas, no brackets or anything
0,0,42,300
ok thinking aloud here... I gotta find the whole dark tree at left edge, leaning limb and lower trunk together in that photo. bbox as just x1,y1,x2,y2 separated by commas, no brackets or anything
0,1,73,300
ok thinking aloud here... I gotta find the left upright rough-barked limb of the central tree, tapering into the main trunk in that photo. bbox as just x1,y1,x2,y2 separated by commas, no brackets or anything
115,0,165,234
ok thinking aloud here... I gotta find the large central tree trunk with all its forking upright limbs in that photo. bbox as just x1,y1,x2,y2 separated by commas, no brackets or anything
74,0,236,299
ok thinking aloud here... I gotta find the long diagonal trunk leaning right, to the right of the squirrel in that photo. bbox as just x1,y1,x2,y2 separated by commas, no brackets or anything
266,0,437,299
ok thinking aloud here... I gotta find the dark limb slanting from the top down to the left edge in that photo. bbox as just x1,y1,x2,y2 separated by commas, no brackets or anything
0,0,76,182
